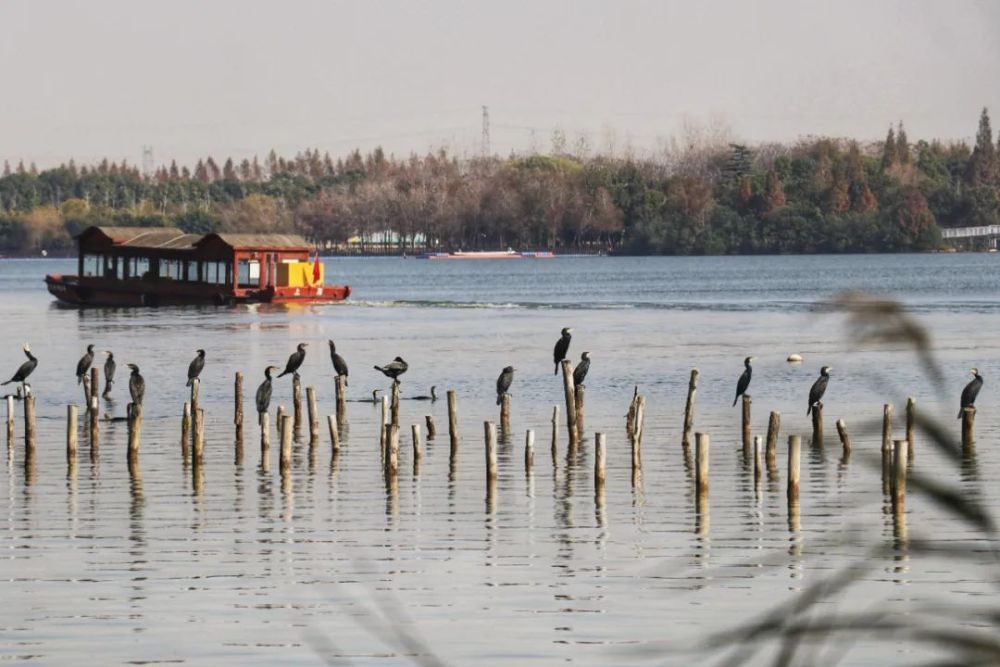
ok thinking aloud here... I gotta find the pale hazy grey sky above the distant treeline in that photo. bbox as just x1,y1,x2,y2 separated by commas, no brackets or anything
0,0,1000,166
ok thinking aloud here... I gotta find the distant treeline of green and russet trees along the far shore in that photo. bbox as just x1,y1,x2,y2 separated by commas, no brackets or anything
0,109,1000,254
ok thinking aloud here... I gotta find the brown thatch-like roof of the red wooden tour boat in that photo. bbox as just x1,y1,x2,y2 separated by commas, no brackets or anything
77,225,312,250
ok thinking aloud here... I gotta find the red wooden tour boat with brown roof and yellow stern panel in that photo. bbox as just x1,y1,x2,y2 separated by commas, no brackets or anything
45,226,351,306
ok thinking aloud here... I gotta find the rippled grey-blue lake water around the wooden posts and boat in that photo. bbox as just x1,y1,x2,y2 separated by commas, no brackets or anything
0,255,1000,665
